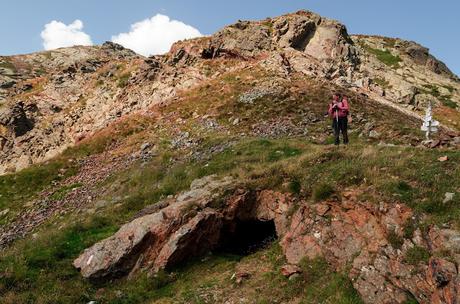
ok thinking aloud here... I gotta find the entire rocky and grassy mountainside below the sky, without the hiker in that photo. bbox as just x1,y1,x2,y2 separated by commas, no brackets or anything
0,11,460,304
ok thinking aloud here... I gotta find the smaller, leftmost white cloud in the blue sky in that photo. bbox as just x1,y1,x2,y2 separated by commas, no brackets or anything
41,19,93,50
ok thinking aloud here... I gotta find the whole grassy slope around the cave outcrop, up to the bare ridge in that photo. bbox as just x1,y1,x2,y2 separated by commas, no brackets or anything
0,71,460,303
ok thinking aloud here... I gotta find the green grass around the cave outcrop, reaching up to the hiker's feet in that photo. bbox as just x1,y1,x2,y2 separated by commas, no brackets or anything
0,135,460,303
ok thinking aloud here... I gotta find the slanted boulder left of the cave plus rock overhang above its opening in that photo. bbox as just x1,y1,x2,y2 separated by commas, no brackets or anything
73,176,292,280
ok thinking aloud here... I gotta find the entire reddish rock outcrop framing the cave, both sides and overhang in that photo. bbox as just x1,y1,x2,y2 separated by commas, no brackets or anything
74,177,460,303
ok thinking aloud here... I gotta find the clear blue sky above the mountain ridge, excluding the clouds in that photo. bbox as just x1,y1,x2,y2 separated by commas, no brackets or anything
0,0,460,75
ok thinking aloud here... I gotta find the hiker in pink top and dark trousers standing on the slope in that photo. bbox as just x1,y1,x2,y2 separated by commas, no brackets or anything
328,93,350,145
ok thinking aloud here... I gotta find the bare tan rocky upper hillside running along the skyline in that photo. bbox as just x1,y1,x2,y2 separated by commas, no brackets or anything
0,12,460,173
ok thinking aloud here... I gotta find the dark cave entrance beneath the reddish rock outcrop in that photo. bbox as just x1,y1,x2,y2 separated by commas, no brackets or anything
217,220,277,255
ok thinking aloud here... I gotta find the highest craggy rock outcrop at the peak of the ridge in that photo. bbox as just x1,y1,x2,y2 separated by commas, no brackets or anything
171,11,359,66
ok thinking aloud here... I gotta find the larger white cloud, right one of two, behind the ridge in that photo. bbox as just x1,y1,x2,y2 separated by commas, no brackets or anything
112,14,202,56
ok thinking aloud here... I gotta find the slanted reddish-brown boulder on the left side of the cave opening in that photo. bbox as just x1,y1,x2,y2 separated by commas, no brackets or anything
74,177,234,279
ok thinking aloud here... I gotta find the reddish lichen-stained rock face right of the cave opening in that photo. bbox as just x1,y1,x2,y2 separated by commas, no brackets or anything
281,192,460,303
